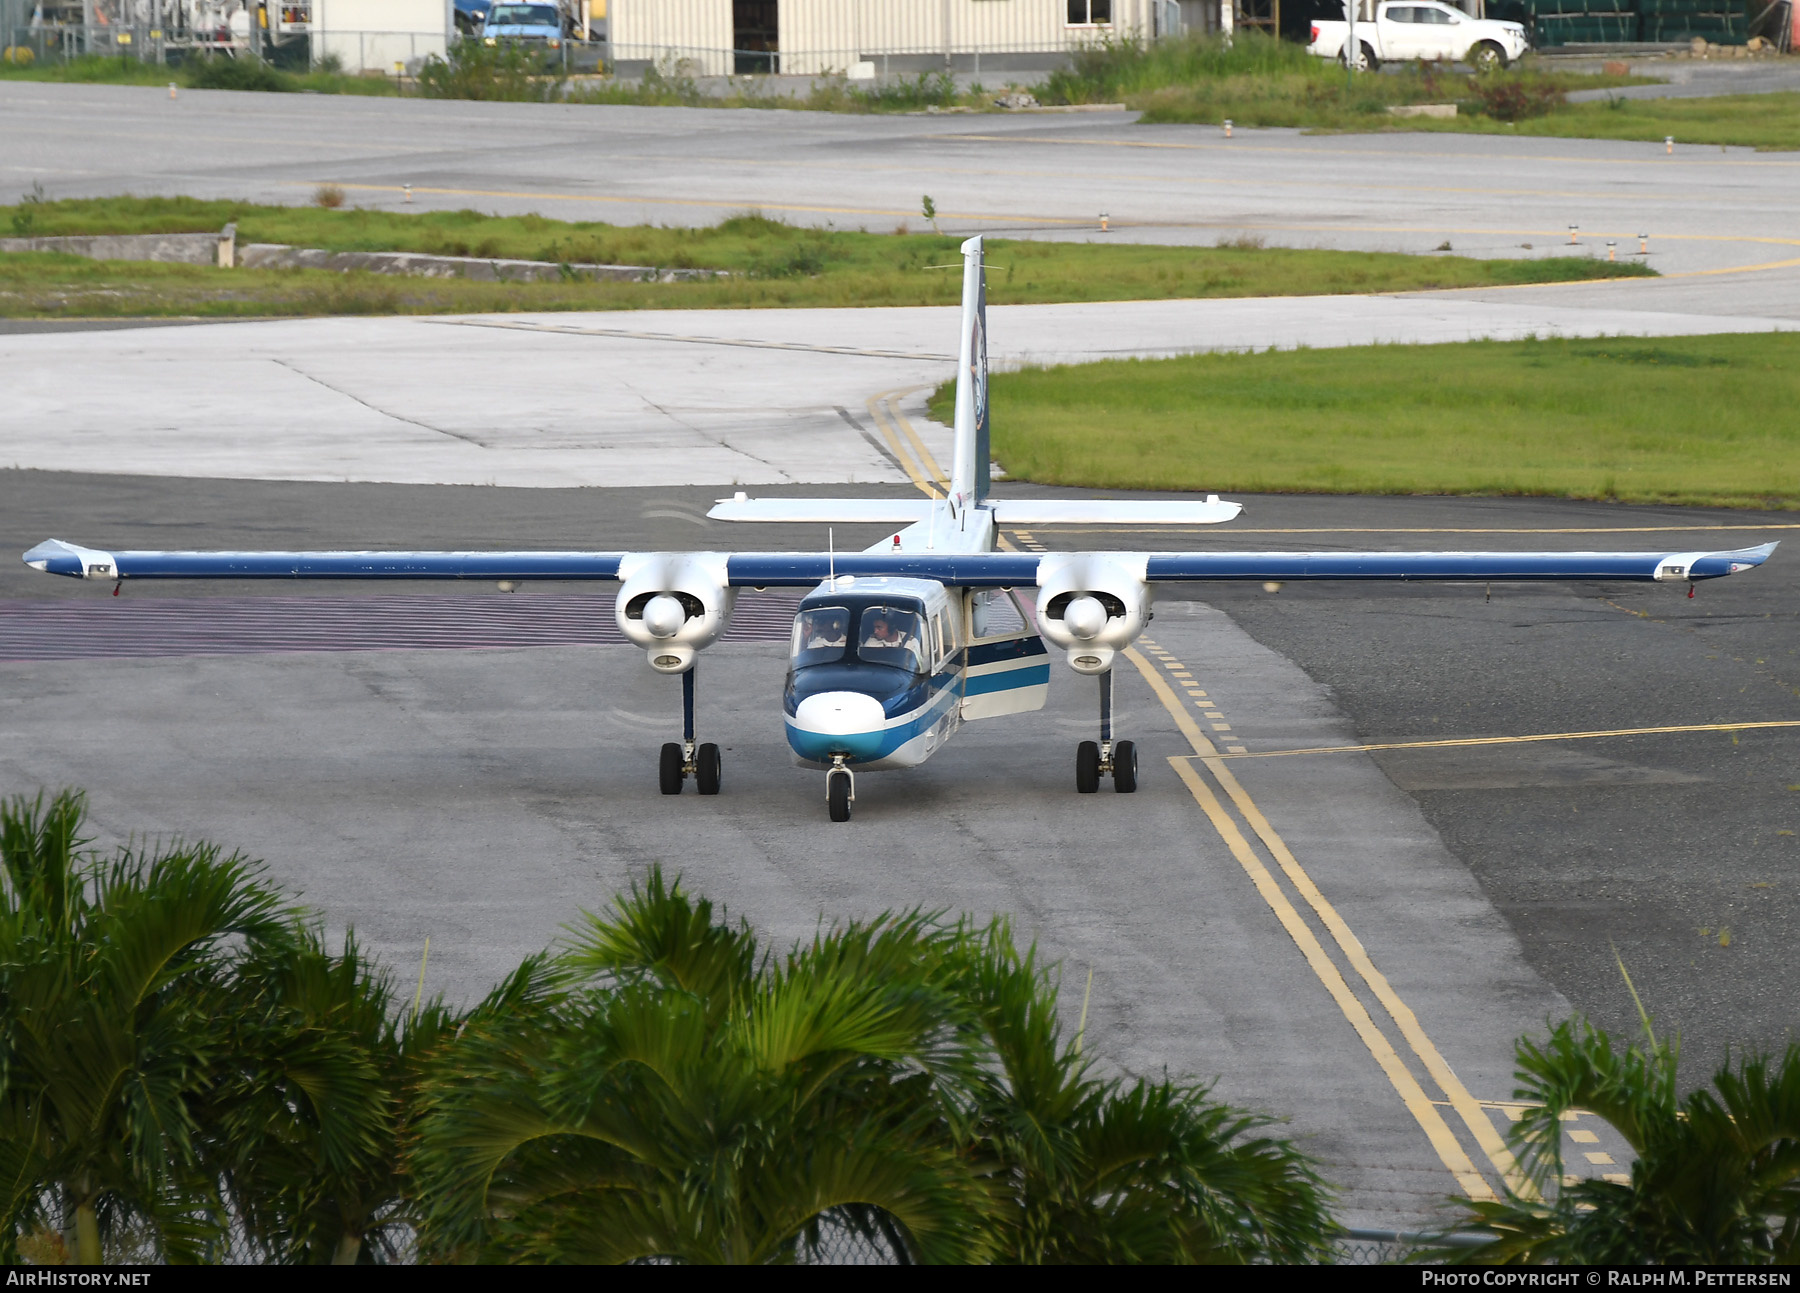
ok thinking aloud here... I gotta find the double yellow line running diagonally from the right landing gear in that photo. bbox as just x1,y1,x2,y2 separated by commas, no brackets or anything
1125,647,1532,1198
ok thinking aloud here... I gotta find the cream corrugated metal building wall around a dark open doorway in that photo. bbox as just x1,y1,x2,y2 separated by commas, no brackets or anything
610,0,1150,76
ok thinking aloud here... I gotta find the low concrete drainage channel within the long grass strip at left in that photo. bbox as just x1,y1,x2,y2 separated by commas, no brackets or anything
0,225,731,283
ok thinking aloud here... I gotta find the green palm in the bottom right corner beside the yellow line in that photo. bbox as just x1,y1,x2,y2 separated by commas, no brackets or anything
1454,1019,1800,1264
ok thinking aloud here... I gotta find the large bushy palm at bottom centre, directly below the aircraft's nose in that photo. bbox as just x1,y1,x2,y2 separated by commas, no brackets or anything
410,872,994,1264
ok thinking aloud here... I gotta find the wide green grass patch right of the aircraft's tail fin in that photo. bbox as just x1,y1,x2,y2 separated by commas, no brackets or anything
932,333,1800,508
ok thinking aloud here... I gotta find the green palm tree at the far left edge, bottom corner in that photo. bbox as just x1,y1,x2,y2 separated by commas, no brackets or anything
0,791,292,1264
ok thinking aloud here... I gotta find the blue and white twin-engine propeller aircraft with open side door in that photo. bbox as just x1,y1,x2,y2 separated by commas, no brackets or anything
25,238,1775,821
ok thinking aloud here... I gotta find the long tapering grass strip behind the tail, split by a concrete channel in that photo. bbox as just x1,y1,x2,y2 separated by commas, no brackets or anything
0,198,1651,317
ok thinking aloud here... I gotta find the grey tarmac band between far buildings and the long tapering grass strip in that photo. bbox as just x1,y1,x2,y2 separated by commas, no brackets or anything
0,81,1800,284
